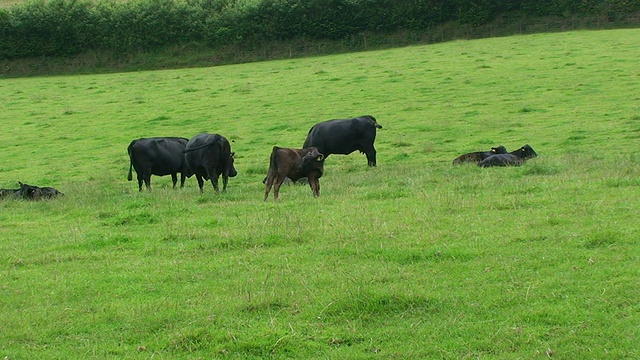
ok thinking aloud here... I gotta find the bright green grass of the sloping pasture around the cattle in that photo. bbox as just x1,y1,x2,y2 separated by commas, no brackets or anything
0,30,640,359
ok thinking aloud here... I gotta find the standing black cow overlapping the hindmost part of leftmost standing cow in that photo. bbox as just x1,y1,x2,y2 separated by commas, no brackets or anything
184,133,238,192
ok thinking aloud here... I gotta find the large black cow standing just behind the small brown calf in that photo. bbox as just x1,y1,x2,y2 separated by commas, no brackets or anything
302,115,382,166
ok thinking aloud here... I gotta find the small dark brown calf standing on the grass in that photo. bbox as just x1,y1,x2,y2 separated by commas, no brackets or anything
264,146,326,201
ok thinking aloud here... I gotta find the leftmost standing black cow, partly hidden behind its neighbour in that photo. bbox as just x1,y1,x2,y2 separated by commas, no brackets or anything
127,137,193,191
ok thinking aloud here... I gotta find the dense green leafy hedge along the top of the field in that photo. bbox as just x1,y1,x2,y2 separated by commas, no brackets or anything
0,0,640,59
